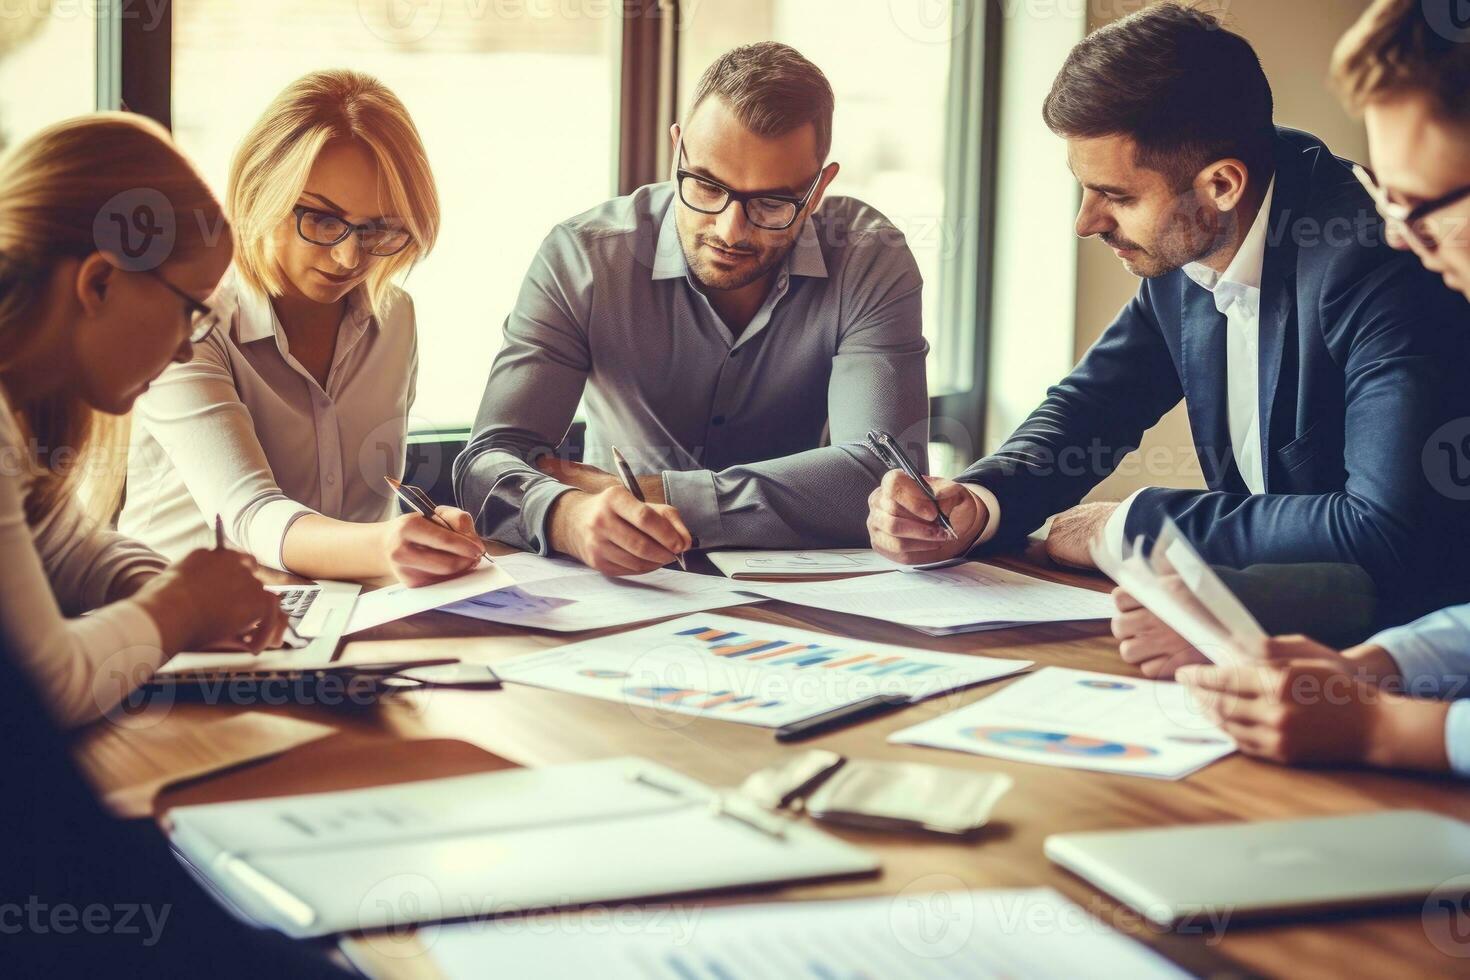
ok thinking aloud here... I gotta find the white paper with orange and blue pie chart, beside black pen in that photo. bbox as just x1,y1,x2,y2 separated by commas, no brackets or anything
888,667,1235,779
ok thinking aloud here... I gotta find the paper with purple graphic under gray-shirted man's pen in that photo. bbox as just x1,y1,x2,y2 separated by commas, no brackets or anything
432,554,761,632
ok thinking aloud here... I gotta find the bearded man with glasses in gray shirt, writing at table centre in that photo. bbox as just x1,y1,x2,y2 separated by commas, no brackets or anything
454,43,928,574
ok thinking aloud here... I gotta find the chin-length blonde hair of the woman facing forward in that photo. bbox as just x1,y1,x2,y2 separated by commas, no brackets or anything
228,69,440,310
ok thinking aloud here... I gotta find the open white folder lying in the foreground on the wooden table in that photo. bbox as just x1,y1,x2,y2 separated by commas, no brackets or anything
168,758,878,937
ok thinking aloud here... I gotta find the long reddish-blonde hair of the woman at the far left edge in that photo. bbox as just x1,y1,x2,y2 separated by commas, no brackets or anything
0,113,229,523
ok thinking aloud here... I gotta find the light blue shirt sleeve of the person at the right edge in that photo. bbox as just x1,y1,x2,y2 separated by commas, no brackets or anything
1369,605,1470,776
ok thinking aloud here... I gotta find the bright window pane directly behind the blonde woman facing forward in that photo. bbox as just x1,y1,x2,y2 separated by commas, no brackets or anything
172,0,620,430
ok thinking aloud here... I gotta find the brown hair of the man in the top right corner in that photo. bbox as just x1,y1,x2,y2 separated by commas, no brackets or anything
1332,0,1470,120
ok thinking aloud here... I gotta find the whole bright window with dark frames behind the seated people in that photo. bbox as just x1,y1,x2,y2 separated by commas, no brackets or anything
80,0,1000,472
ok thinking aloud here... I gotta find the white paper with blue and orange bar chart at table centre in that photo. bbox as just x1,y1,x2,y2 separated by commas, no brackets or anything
495,613,1030,727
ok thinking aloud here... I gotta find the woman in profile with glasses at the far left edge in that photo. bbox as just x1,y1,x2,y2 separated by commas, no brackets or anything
0,113,285,726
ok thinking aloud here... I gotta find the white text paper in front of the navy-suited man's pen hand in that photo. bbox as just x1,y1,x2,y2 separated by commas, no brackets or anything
741,561,1113,636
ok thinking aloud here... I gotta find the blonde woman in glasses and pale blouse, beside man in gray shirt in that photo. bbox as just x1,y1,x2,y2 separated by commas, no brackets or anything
119,71,482,586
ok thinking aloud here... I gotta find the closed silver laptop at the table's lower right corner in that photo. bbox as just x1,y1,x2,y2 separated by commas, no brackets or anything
1045,810,1470,927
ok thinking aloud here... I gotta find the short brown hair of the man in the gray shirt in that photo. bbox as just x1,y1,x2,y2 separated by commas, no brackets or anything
689,41,835,162
